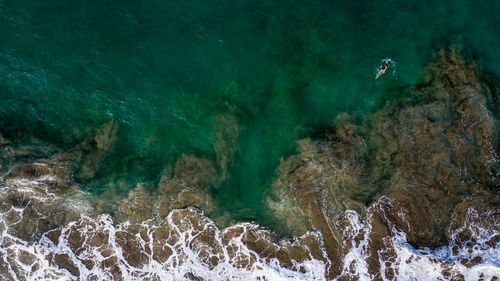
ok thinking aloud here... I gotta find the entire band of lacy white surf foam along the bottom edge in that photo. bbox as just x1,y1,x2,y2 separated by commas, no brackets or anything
0,178,500,280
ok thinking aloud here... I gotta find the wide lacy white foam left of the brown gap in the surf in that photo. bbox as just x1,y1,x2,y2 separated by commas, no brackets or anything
0,175,326,280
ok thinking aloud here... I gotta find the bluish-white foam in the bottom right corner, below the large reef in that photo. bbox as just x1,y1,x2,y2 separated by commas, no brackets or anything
338,198,500,281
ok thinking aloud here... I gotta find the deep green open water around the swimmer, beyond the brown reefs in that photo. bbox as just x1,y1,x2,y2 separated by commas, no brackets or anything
0,0,500,223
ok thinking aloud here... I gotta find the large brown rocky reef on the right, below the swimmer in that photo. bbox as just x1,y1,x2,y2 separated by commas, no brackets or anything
268,50,500,276
